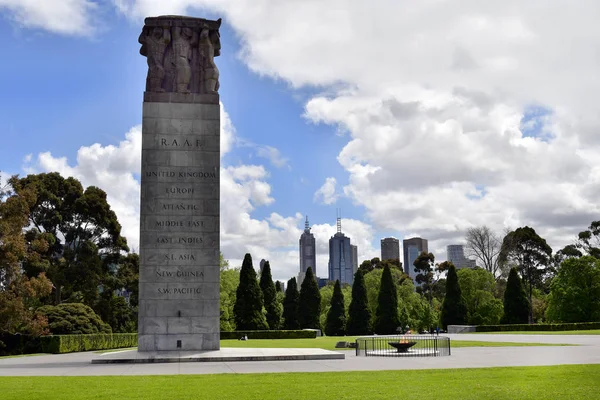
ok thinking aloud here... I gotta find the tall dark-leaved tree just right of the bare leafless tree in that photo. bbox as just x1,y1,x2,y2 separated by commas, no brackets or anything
498,226,552,323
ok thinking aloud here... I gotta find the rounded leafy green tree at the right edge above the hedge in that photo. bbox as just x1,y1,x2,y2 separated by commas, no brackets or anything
546,256,600,322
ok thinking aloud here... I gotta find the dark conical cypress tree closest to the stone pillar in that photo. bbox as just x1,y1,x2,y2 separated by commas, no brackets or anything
233,253,269,331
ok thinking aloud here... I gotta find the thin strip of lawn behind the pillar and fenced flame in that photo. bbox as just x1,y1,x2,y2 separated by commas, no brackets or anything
221,336,568,350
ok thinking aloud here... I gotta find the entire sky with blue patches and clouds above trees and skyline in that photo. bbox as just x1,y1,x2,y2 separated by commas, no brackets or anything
0,0,600,279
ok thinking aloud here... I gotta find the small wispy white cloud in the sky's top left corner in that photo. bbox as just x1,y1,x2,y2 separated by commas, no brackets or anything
0,0,98,36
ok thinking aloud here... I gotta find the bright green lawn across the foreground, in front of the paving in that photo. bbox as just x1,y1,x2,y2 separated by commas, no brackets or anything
0,365,600,400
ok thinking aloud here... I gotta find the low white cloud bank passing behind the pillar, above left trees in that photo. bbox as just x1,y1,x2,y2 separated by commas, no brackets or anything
23,107,324,280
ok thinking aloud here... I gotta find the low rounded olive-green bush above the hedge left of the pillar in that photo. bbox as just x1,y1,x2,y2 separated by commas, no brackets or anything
38,303,112,335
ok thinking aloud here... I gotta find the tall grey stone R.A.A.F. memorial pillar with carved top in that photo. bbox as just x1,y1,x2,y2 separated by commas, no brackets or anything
137,16,221,351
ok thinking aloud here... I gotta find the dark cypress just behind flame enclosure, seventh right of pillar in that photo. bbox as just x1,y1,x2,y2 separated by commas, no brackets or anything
373,264,400,335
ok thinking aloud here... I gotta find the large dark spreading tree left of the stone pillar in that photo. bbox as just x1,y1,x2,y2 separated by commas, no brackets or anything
10,172,129,306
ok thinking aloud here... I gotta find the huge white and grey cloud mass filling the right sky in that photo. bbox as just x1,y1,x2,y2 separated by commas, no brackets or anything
110,0,600,255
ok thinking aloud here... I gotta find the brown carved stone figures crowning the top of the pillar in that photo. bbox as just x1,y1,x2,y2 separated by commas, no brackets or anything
138,16,221,94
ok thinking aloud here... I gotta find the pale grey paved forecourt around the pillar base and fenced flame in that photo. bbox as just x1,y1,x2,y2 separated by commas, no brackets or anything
0,335,600,376
